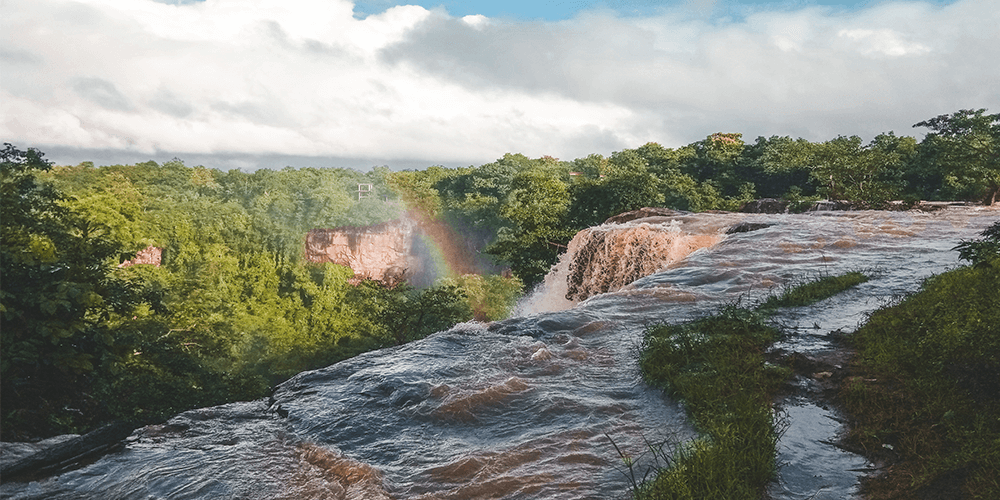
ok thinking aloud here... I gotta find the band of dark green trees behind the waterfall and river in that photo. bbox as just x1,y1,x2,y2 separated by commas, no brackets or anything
389,109,1000,286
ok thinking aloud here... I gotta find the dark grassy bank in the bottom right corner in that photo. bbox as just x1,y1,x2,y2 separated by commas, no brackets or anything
842,266,1000,499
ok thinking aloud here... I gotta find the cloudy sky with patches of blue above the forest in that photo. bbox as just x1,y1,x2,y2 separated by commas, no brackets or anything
0,0,1000,170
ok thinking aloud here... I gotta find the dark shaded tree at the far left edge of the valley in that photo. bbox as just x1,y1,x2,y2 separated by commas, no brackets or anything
0,144,159,438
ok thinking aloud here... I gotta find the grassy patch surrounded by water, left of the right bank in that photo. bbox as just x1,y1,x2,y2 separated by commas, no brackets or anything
636,306,788,499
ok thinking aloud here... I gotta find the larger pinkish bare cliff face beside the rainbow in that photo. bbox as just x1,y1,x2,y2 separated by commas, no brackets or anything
305,219,420,285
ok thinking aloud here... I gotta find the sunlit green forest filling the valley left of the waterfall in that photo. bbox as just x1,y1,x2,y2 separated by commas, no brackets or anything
0,144,520,440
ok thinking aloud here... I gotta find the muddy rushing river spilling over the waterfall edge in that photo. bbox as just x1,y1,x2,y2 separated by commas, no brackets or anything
0,208,1000,499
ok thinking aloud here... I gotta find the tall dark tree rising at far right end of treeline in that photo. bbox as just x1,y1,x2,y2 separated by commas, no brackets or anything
913,109,1000,205
